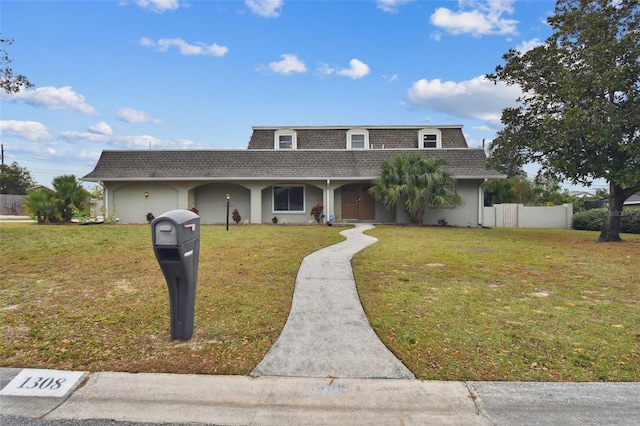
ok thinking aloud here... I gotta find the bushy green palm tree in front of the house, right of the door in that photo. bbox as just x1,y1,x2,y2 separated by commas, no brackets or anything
369,153,462,225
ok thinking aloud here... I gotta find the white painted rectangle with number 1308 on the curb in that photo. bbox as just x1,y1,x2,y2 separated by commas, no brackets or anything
0,368,86,397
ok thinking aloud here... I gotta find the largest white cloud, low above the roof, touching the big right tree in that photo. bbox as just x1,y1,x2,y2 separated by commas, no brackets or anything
407,76,522,127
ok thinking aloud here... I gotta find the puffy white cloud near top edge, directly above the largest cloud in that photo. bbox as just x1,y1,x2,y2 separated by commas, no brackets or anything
431,0,518,37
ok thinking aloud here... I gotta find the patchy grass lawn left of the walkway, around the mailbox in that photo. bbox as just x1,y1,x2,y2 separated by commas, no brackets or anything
0,224,344,374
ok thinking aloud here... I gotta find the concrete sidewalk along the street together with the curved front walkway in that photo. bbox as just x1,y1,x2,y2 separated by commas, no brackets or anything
0,225,640,426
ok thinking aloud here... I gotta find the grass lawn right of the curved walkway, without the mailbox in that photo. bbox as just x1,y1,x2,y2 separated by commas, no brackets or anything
353,226,640,381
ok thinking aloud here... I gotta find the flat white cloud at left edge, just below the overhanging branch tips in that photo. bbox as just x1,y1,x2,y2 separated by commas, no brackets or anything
0,86,97,115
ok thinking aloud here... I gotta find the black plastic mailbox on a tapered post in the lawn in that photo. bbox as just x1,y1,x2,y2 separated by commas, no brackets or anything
151,210,200,340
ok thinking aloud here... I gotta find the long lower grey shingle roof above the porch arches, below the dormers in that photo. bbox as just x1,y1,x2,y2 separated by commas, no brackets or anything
83,148,501,181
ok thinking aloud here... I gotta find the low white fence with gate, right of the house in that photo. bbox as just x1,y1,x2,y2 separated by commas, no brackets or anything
482,204,573,229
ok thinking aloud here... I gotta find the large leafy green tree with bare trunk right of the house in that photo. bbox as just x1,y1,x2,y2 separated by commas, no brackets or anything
487,0,640,241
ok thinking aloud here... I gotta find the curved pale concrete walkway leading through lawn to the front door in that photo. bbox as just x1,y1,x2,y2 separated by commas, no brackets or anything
251,224,415,379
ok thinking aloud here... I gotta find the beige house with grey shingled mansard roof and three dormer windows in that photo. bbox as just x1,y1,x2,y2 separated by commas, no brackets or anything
83,126,504,227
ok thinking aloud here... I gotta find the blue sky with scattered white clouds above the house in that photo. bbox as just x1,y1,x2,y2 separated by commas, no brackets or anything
0,0,600,191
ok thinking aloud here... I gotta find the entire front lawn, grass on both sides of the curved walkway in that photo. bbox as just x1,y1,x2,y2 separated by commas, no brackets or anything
0,223,640,381
